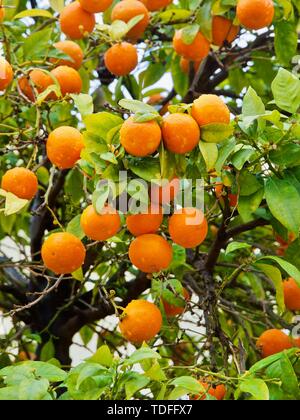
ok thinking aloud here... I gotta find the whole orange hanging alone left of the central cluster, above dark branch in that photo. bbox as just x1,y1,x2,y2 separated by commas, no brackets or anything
46,126,84,169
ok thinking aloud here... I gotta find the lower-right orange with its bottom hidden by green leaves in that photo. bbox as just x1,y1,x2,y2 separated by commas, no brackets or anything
256,329,293,357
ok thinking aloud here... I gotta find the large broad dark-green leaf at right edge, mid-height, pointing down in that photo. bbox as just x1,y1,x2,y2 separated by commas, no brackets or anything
265,177,300,234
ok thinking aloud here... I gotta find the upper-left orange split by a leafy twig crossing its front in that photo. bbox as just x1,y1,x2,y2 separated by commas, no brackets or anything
18,69,54,102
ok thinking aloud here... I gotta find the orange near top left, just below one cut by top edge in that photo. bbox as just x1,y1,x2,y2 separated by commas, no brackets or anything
59,1,96,39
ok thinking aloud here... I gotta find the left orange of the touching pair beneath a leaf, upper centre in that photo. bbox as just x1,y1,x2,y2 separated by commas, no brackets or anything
120,116,161,157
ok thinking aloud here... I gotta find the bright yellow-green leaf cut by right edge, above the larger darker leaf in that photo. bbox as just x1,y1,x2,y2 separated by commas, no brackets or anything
271,68,300,114
